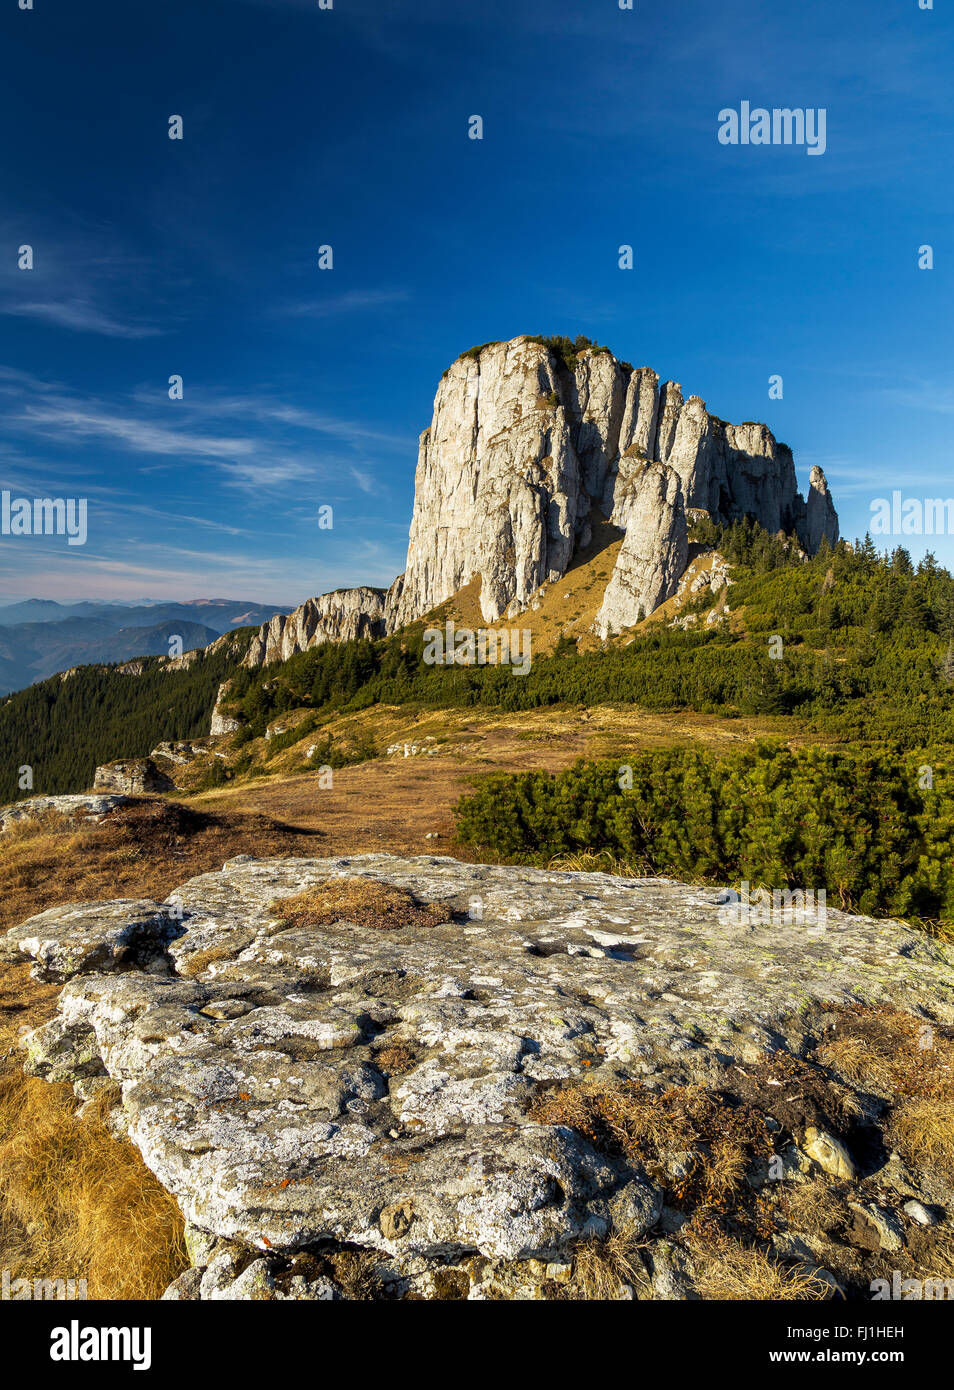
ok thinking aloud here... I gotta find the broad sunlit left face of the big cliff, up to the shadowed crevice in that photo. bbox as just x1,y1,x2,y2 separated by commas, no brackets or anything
388,338,597,630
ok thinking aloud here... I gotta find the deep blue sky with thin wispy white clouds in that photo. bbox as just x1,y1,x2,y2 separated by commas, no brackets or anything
0,0,954,603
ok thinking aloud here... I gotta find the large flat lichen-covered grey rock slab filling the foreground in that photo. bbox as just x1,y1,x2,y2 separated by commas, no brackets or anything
7,855,954,1298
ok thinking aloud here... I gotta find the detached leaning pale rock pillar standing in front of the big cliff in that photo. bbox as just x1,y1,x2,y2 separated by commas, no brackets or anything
595,463,688,637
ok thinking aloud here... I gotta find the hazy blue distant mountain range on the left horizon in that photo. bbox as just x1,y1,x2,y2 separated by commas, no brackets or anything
0,599,289,695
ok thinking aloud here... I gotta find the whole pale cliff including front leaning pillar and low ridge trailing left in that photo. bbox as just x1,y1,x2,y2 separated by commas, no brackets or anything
196,336,839,667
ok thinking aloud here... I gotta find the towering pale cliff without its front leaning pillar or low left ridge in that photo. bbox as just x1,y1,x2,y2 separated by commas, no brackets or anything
388,338,837,631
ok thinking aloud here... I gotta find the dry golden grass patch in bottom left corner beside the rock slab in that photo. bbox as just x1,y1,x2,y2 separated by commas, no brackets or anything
0,1072,189,1298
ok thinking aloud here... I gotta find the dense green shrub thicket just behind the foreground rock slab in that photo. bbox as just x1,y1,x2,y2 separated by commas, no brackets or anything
456,744,954,920
